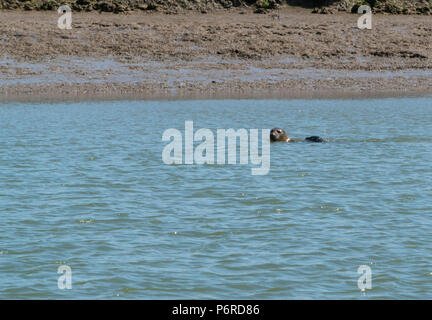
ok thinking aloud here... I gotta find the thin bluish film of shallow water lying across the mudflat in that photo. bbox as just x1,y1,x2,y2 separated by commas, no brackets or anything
0,57,432,86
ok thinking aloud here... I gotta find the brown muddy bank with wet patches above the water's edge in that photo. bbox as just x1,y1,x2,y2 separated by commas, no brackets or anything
0,8,432,101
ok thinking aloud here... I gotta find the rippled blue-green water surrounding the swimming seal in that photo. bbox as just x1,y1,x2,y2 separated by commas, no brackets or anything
0,98,432,299
